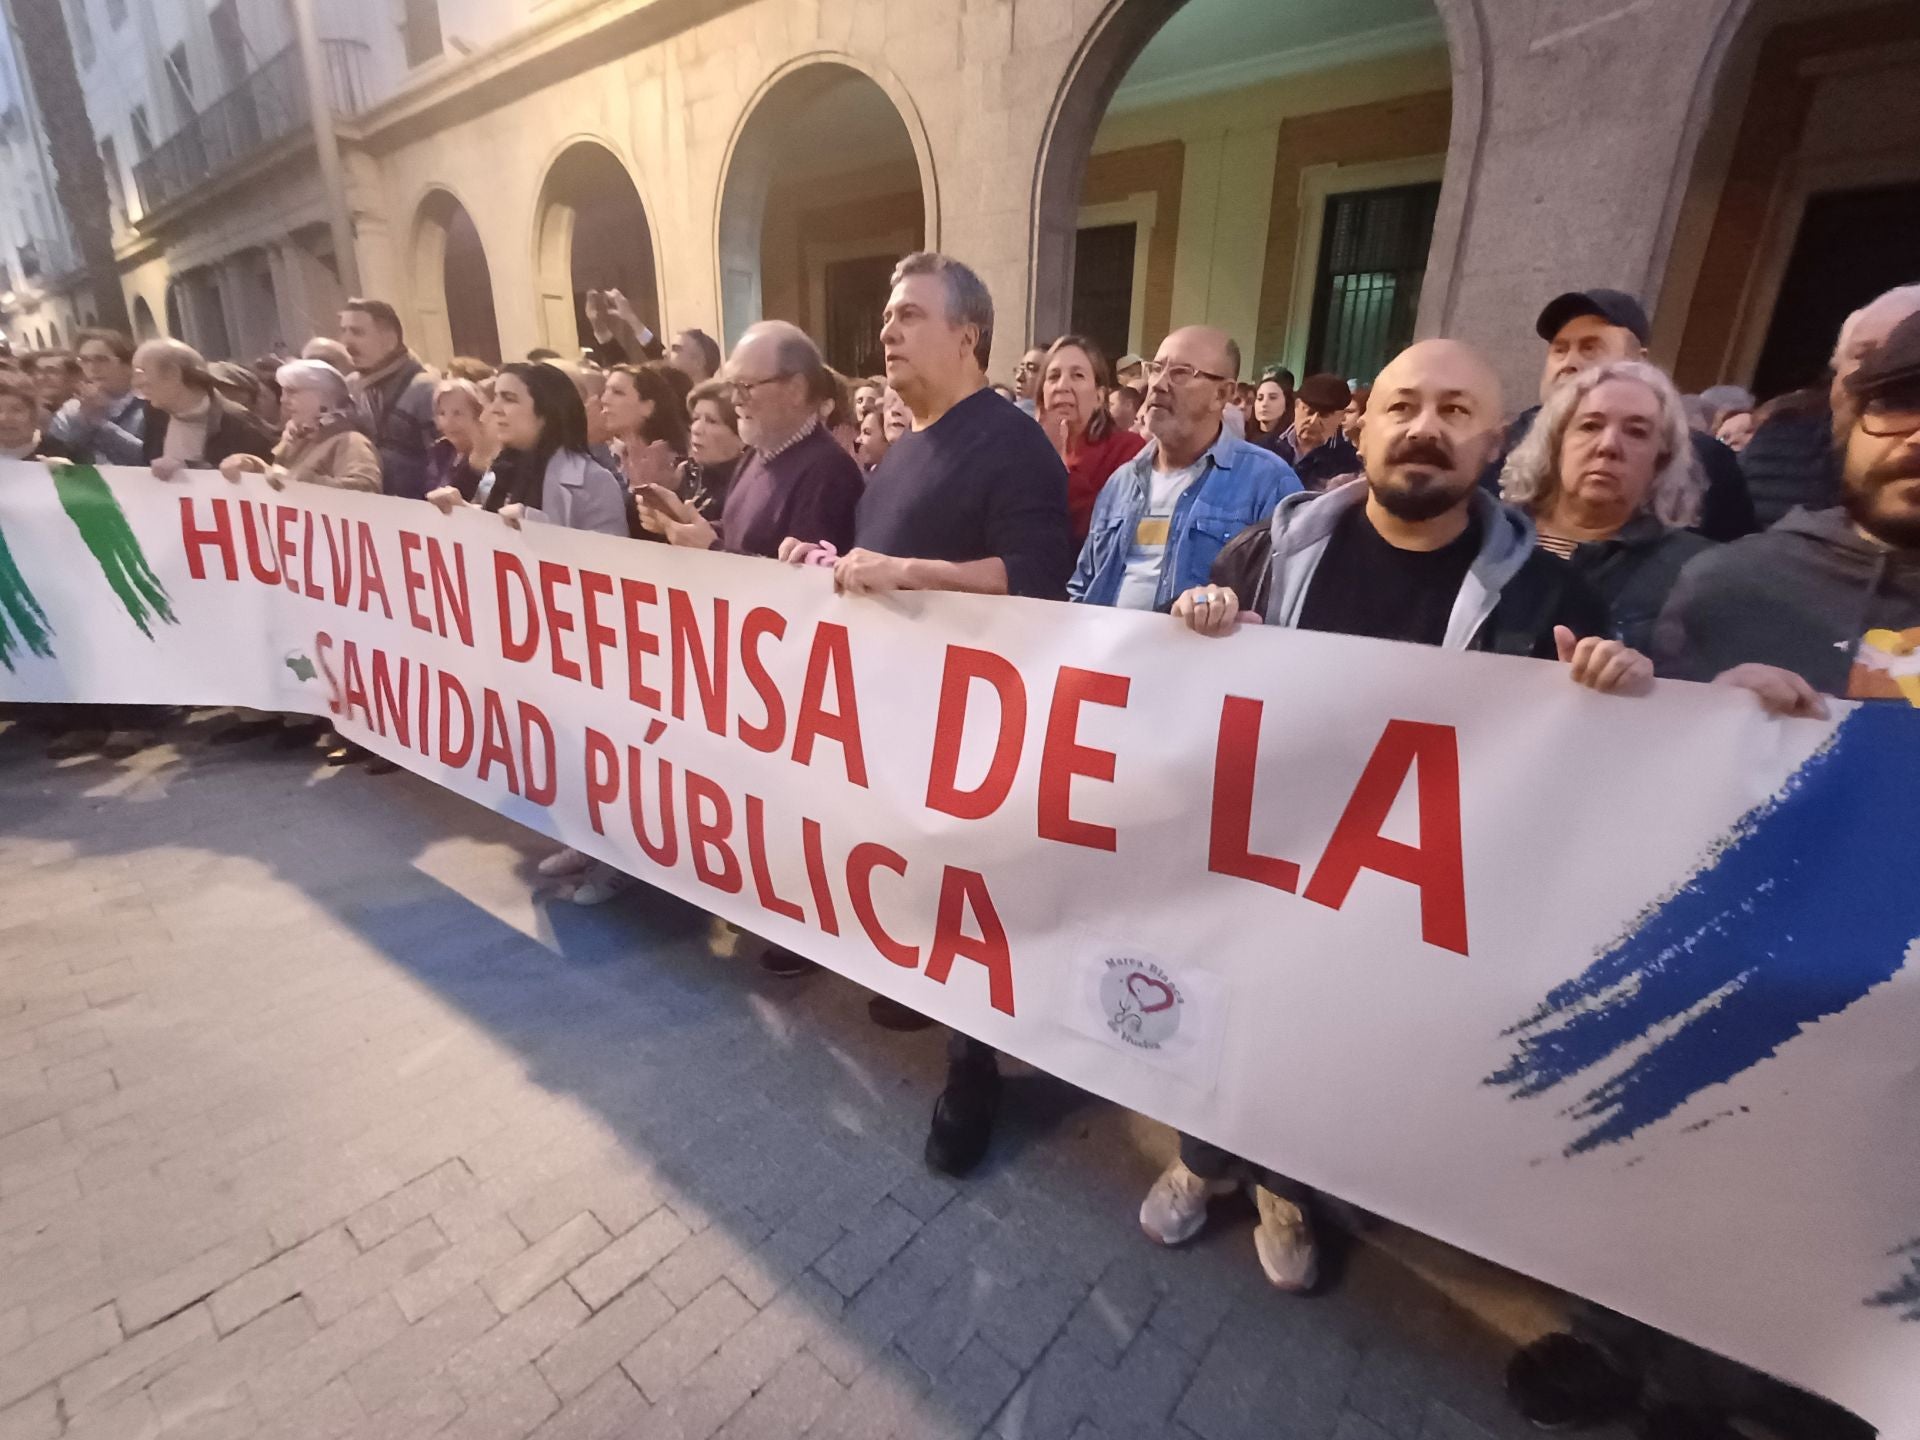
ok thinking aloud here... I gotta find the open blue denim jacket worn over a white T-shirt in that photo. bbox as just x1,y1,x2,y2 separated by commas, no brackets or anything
1068,426,1300,611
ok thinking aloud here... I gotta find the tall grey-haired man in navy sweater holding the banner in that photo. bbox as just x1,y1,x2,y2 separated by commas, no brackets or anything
780,252,1073,1175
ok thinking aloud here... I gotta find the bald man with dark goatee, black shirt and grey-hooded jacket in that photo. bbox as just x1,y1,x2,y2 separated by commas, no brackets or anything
1140,340,1653,1292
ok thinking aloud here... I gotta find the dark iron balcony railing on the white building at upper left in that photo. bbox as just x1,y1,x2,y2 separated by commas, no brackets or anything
132,40,367,211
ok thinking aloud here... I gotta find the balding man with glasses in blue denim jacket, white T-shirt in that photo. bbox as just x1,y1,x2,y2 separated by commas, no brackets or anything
1068,324,1300,611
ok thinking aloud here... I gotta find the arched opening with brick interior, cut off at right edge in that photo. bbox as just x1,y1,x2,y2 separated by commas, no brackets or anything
1655,0,1920,399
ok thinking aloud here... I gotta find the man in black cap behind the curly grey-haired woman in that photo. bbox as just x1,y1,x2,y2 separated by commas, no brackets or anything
1480,290,1755,540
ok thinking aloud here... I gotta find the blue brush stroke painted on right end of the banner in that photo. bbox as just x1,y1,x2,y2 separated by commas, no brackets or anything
1486,703,1920,1154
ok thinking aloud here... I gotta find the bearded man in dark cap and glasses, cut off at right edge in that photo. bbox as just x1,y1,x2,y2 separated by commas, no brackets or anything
1653,313,1920,714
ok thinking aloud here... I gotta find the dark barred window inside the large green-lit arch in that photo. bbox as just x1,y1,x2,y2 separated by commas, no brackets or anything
1306,180,1440,384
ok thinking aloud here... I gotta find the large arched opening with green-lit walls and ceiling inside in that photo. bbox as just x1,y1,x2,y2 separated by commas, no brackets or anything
1036,0,1453,382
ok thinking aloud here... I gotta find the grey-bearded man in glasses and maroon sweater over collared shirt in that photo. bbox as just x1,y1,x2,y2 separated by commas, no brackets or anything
637,321,862,559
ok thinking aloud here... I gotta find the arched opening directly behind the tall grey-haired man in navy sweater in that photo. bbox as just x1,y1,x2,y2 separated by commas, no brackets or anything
718,61,939,374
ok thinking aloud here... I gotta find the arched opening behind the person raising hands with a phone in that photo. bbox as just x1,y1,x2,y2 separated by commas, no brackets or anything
534,140,660,353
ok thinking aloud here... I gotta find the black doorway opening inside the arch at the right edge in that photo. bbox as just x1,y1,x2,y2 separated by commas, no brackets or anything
1753,184,1920,399
